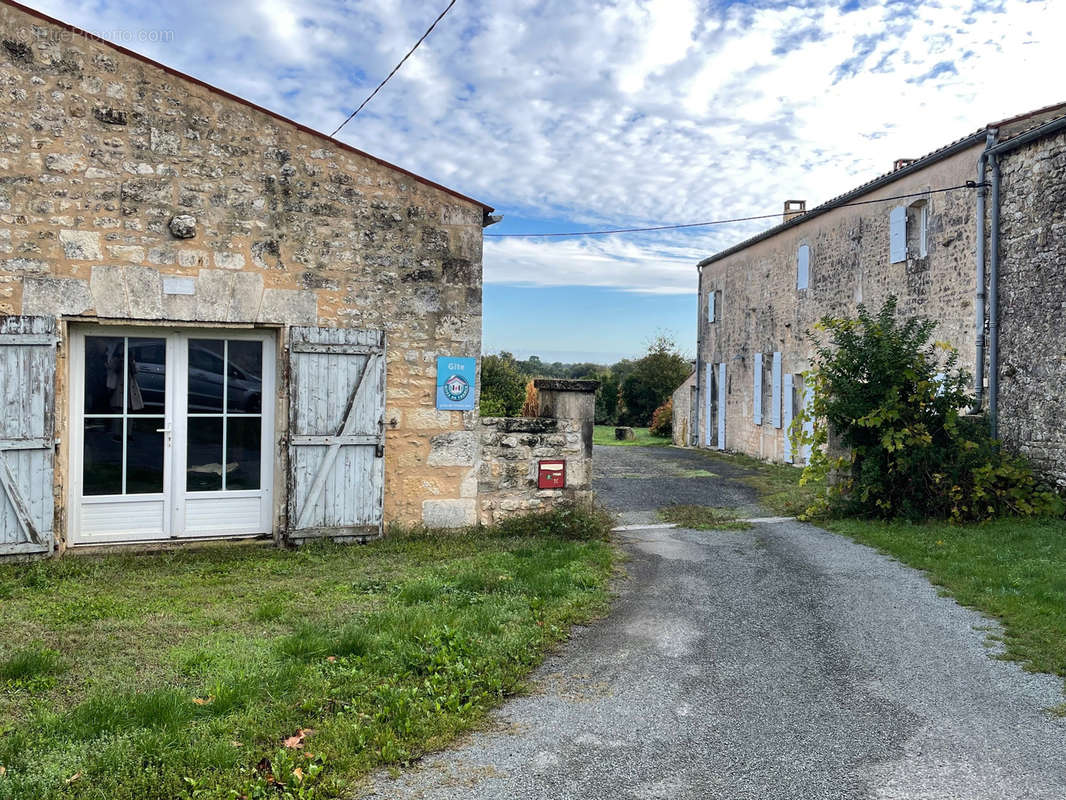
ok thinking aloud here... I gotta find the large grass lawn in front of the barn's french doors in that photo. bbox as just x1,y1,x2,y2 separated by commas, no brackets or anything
0,515,613,800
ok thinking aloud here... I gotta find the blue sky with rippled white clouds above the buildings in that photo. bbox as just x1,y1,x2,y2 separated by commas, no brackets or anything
22,0,1066,361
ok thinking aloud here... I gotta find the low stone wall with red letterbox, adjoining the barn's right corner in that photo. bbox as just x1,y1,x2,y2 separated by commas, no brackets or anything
478,417,592,525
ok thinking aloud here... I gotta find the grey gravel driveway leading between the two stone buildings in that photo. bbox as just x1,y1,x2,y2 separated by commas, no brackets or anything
366,447,1066,800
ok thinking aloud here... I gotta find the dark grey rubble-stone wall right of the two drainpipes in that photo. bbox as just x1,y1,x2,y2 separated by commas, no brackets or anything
999,128,1066,487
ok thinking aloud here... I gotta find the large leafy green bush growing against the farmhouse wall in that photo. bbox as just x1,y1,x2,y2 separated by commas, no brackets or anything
792,298,1063,522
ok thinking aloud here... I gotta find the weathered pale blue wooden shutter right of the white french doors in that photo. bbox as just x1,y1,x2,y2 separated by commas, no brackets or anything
288,327,385,539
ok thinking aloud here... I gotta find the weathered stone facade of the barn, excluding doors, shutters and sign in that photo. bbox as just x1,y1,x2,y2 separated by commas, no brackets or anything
0,4,490,546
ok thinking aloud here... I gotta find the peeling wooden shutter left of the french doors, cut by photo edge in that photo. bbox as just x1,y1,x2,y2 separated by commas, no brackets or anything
0,317,55,556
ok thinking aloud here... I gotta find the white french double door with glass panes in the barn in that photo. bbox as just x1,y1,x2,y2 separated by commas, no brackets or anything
68,326,275,544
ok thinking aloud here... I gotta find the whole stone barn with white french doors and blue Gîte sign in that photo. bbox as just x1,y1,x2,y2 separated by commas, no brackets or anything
0,2,491,555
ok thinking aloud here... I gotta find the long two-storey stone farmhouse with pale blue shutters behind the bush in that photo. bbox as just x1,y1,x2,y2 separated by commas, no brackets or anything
675,103,1066,484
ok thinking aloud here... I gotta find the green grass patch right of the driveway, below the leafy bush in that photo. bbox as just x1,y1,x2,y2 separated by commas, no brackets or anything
820,519,1066,691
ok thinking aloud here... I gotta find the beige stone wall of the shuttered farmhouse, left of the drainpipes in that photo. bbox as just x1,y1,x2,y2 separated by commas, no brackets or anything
699,145,981,461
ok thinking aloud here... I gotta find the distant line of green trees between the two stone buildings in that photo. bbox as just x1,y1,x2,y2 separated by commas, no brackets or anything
481,336,692,428
